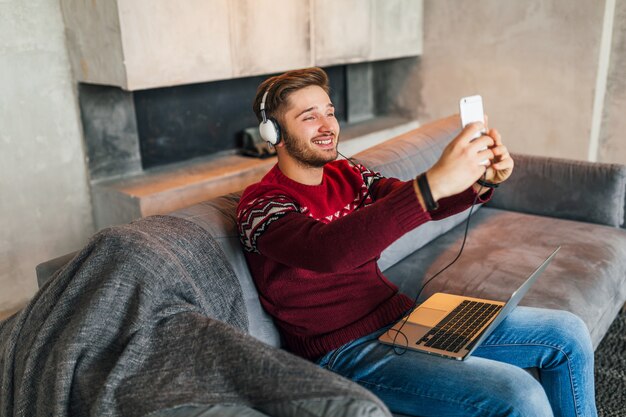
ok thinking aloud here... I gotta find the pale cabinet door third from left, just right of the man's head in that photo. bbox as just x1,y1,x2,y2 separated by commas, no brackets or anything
312,0,372,66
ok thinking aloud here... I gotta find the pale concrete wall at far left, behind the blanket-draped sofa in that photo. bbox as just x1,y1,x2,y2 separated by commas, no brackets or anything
0,0,93,311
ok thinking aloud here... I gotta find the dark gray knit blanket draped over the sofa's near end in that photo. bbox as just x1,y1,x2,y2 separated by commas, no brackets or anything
0,216,389,417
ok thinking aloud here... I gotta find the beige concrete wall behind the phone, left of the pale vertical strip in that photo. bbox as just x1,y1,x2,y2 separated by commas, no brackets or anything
416,0,608,159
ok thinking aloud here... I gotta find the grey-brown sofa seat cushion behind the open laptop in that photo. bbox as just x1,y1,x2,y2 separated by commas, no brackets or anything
385,207,626,346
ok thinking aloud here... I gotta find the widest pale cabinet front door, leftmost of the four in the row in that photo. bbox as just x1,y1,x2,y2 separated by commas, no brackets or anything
118,0,233,90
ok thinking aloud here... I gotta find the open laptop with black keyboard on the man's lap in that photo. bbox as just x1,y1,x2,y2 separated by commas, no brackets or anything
378,246,561,360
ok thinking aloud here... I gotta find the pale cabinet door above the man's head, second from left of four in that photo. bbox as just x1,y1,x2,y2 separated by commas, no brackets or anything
231,0,313,77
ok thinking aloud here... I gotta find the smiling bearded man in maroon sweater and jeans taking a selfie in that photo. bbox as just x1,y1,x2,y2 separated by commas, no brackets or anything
237,68,596,417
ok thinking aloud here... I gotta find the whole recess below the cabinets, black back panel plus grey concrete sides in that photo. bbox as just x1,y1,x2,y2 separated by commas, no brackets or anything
78,57,419,182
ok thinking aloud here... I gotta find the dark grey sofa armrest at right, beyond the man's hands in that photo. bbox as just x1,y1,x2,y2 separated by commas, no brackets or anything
488,154,626,227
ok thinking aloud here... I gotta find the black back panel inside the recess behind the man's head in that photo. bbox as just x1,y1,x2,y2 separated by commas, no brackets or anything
134,66,346,169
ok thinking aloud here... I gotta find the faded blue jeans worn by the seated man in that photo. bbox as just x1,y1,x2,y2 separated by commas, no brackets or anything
317,307,597,417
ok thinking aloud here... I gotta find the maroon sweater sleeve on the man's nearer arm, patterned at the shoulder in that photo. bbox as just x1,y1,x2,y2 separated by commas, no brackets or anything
239,182,430,272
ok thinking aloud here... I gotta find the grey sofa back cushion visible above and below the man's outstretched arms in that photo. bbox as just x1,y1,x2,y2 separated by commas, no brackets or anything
354,116,479,271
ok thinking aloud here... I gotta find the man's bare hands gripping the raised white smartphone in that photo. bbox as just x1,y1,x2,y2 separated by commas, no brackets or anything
426,122,494,201
